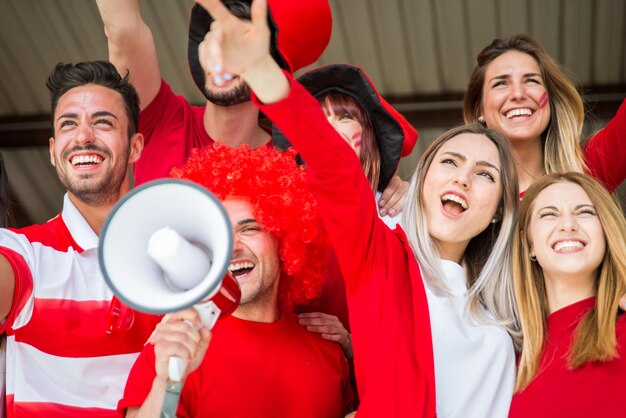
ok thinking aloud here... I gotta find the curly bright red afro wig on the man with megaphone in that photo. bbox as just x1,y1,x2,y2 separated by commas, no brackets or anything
170,142,330,310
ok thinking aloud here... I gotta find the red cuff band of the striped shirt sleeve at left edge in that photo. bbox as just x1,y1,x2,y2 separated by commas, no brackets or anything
0,247,33,334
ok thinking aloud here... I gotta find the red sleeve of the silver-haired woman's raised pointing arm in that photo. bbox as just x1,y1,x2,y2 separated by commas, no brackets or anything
253,73,387,292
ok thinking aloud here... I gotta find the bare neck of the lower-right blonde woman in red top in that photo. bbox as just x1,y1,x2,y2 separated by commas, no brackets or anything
544,272,596,313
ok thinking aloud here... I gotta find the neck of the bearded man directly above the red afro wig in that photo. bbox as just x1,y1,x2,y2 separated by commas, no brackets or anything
204,101,271,148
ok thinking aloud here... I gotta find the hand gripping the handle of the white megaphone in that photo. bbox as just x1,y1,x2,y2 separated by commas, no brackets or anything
148,308,211,381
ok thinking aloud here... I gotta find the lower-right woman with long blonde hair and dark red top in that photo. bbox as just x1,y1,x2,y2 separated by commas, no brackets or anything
510,173,626,418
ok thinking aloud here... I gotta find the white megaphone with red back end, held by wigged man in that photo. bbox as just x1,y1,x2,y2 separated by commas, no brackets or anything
98,179,241,382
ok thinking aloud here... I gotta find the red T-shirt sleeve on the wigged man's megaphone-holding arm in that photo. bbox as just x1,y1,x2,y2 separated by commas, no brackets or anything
117,344,156,417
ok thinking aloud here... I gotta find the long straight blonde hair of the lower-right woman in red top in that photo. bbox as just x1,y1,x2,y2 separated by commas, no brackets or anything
513,172,626,391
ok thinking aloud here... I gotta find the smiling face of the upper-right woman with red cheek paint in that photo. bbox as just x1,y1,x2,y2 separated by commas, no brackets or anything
481,51,550,145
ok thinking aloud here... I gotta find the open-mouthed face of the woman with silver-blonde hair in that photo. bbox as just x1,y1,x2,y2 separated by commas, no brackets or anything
422,133,502,262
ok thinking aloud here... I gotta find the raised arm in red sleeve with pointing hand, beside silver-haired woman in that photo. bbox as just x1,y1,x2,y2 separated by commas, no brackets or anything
199,0,389,290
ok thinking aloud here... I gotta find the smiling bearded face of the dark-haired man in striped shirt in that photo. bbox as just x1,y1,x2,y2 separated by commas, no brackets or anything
50,84,143,206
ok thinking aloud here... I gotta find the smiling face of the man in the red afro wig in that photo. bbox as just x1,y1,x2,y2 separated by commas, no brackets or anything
224,199,280,309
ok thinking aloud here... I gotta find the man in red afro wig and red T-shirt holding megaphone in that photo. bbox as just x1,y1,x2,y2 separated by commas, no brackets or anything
119,143,353,418
